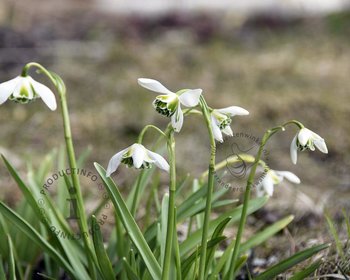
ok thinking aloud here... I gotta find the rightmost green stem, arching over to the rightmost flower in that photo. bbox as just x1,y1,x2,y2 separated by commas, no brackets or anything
226,120,304,279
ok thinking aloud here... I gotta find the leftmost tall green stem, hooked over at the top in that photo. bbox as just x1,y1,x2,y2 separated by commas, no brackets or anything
22,62,97,279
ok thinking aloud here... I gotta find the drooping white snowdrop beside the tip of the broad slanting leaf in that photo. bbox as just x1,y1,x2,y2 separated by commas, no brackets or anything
106,144,169,177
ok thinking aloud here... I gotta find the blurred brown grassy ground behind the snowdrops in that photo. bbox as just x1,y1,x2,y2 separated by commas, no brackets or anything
0,0,350,258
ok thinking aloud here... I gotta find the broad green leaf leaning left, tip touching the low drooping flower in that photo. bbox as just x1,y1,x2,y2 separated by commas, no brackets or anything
95,163,162,280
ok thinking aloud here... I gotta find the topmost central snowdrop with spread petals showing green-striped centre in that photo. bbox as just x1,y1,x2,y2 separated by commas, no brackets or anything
137,78,202,132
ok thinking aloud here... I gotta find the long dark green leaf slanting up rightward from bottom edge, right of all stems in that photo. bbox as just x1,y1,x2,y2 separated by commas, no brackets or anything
254,244,330,280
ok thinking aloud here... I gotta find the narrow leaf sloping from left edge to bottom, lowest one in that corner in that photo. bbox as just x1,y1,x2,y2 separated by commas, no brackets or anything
0,201,79,279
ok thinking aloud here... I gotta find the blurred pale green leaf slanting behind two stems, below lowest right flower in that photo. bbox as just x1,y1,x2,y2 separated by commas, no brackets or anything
180,196,268,258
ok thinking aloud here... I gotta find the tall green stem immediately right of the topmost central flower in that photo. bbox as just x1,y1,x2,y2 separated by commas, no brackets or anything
198,96,216,280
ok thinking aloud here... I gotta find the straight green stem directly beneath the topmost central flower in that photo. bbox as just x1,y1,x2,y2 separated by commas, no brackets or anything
162,130,176,280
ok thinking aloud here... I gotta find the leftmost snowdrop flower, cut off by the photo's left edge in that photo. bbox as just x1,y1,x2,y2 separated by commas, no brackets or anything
0,76,57,111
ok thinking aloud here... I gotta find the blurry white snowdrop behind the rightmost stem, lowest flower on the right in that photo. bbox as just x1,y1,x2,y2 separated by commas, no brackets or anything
256,169,300,196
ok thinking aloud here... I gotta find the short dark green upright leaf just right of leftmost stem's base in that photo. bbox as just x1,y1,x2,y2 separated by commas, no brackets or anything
91,216,115,280
